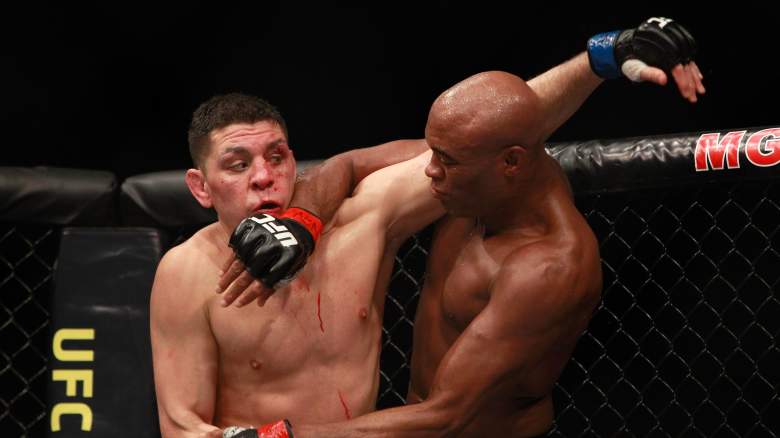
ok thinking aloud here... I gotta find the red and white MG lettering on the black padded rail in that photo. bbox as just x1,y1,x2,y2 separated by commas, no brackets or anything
694,128,780,172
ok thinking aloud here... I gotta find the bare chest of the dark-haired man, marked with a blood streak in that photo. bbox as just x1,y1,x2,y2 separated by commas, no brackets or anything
209,266,375,371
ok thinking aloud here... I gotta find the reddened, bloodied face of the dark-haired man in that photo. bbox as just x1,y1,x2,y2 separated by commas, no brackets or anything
203,121,295,229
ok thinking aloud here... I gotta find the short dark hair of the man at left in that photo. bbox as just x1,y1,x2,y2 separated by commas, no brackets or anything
187,93,287,167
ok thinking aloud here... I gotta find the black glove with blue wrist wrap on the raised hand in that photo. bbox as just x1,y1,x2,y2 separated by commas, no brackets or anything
588,17,696,81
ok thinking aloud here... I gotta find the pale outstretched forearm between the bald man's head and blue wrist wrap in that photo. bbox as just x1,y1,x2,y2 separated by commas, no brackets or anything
528,52,604,141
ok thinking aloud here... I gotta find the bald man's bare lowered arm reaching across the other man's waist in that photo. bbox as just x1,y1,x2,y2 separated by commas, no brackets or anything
293,248,598,438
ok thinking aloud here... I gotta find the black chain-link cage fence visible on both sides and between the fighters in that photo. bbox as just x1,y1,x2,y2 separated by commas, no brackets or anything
0,182,780,437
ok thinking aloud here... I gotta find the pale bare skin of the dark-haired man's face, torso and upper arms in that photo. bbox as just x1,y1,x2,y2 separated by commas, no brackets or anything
151,122,443,437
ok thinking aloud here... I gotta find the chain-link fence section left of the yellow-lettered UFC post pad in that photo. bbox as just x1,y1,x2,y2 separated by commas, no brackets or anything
0,224,60,437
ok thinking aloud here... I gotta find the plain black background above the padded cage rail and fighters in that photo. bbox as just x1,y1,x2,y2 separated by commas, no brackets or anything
0,1,780,178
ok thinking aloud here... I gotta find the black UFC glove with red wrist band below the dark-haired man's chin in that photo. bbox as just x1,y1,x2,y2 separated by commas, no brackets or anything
230,208,322,288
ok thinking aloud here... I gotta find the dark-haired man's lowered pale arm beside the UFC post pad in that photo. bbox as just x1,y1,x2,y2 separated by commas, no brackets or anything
150,248,219,438
